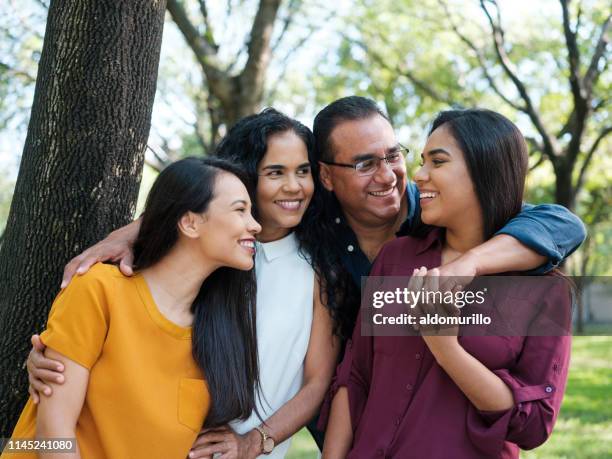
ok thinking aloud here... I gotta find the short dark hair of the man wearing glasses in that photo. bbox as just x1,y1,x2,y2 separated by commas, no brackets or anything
312,96,391,161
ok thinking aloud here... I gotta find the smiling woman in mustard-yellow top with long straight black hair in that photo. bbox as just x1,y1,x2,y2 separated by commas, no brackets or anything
2,158,261,459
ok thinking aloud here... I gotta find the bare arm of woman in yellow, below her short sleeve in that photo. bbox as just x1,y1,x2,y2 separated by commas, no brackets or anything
36,348,89,459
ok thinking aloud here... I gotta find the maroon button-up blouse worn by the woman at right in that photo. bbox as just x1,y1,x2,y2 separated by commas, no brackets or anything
320,231,571,459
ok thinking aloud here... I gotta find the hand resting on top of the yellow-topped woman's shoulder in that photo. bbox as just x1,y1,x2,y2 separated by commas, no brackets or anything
61,219,140,288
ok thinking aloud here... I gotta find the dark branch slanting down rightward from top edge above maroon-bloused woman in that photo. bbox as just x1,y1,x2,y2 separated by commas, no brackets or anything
480,0,557,163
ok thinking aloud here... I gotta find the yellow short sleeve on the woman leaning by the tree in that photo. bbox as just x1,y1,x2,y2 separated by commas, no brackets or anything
41,266,109,370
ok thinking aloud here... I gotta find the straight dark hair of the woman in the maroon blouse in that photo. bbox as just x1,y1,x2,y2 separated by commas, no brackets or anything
429,108,528,239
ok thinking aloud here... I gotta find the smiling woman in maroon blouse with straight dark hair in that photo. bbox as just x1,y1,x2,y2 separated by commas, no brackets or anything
323,109,571,459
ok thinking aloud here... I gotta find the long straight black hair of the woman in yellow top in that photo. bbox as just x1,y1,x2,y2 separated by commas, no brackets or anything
133,158,259,427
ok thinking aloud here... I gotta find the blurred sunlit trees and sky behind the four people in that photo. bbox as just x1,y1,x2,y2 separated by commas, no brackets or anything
0,0,612,457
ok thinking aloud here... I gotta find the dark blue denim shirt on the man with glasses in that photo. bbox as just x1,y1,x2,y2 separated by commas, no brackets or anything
334,181,586,285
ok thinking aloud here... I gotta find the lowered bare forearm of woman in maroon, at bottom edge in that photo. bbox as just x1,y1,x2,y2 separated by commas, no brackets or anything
323,387,353,459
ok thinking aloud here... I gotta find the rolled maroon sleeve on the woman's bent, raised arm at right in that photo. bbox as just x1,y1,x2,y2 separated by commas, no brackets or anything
467,276,571,453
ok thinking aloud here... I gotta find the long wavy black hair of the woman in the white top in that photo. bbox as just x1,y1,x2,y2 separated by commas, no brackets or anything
215,108,355,335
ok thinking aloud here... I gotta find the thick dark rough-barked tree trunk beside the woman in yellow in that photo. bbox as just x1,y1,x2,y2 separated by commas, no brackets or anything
0,0,166,437
